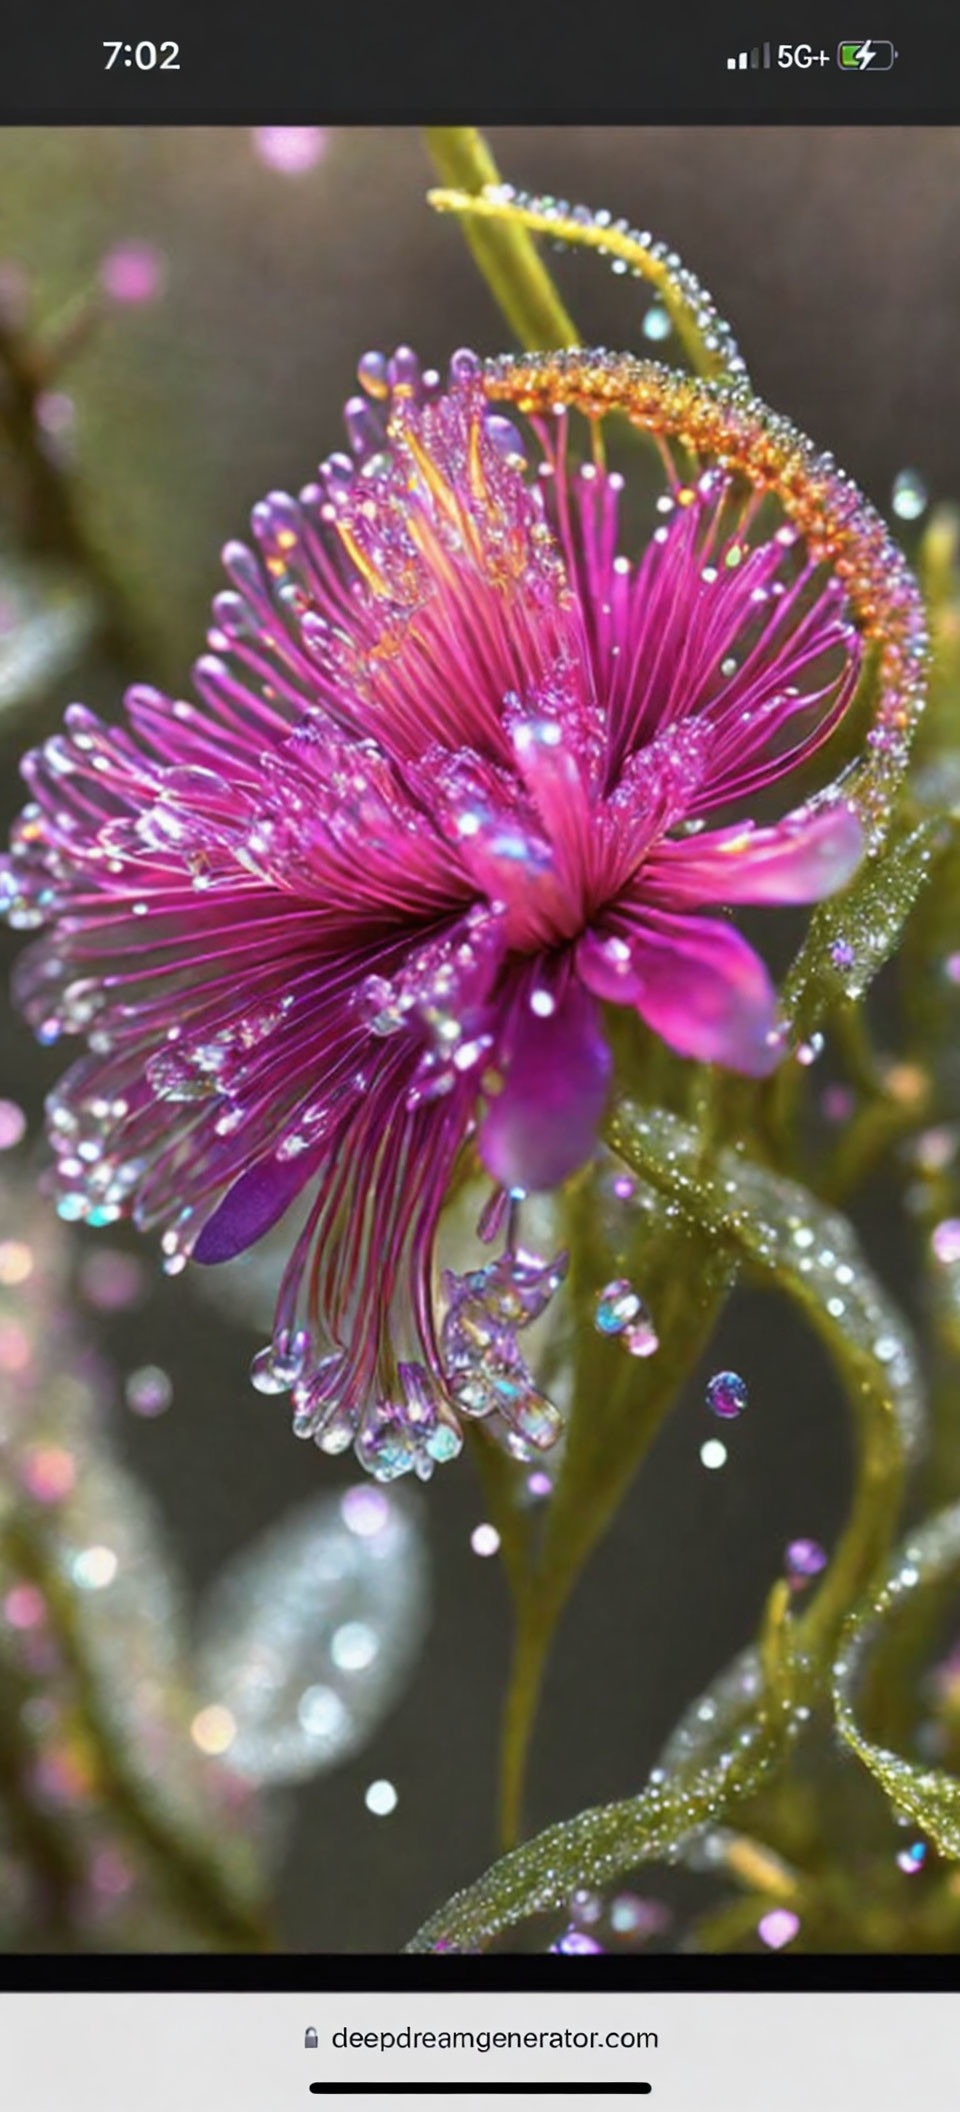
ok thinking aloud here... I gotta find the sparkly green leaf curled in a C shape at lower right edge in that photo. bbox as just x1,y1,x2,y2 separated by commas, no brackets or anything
833,1504,960,1856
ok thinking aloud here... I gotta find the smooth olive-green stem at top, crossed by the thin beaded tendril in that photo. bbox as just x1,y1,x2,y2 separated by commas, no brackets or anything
424,125,580,353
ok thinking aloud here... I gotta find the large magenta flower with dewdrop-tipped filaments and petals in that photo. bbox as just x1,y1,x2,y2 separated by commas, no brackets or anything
6,348,877,1478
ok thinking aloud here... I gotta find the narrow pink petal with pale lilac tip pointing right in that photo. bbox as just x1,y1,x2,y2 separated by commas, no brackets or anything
644,803,863,906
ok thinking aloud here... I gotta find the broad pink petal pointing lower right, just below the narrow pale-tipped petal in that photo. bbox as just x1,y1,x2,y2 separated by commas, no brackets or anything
576,910,781,1077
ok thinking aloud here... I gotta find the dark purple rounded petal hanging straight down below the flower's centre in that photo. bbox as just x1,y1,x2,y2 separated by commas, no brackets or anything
479,978,612,1189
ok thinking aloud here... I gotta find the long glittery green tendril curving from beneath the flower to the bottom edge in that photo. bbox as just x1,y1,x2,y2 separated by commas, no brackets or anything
409,1105,922,1949
